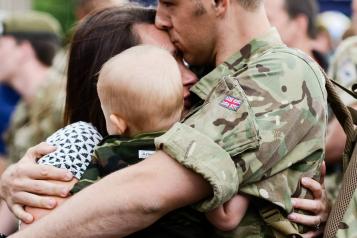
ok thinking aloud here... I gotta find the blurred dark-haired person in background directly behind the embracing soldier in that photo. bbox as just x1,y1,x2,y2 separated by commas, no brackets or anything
264,0,328,70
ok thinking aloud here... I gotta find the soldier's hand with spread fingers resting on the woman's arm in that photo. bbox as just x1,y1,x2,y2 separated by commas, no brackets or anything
0,143,73,223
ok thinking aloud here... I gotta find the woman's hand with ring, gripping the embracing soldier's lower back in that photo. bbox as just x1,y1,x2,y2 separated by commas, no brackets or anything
288,162,331,238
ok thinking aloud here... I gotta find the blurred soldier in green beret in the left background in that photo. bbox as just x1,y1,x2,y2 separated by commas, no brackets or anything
0,12,62,165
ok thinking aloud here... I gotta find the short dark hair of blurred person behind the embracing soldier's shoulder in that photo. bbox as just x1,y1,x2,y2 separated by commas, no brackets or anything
285,0,319,39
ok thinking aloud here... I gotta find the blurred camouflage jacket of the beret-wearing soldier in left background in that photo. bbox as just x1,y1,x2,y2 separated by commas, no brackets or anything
5,52,67,163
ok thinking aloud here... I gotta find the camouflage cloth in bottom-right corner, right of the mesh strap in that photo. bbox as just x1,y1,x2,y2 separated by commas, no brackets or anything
336,188,357,238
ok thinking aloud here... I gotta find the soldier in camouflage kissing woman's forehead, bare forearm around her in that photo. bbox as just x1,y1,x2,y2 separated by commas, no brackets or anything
4,0,327,237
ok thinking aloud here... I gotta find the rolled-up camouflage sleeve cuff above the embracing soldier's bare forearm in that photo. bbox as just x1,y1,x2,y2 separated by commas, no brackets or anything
155,123,238,211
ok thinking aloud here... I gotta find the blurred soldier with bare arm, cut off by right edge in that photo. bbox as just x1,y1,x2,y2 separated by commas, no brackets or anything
326,37,357,238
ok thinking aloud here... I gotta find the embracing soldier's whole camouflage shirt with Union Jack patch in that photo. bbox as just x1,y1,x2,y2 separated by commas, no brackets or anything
155,29,327,237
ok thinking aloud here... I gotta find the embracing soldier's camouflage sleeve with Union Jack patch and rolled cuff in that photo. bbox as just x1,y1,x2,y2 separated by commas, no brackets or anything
155,77,260,211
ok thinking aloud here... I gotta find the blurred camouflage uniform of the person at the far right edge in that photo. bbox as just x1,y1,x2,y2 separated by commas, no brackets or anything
326,36,357,238
